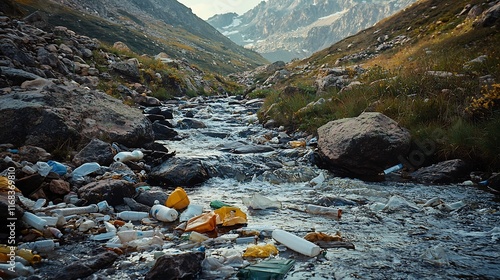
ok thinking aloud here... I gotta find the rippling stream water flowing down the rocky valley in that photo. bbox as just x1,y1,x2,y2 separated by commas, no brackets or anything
159,95,500,279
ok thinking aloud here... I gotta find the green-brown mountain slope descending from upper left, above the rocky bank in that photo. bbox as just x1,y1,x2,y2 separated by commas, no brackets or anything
4,0,266,74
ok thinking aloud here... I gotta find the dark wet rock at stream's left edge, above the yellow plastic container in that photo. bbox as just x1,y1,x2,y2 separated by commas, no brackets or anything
149,158,209,186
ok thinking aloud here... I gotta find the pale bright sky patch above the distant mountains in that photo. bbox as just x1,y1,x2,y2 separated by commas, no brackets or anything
177,0,262,20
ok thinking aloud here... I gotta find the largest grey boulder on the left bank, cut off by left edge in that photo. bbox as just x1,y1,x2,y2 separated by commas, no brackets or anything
0,85,154,152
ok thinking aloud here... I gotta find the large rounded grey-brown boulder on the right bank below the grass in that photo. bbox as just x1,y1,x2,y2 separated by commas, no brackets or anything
318,112,411,179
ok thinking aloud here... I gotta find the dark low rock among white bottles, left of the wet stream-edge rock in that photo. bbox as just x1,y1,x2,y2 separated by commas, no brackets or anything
78,179,136,206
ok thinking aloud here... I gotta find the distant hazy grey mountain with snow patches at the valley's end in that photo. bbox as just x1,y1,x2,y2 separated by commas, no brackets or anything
207,0,416,61
